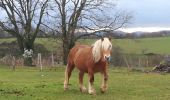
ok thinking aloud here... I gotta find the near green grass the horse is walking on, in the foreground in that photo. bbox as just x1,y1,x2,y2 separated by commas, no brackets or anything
0,66,170,100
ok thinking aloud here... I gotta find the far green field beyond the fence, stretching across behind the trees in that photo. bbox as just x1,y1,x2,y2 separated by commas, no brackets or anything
0,37,170,54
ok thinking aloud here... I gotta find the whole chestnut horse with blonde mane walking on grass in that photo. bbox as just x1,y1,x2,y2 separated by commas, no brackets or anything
64,37,112,95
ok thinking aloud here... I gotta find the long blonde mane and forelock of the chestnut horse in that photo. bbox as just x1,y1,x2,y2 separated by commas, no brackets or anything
92,38,112,62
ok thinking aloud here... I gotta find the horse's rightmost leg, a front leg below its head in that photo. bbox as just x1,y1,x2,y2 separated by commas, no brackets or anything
100,71,108,93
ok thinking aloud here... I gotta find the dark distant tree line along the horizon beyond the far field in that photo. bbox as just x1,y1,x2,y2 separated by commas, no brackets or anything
0,29,170,39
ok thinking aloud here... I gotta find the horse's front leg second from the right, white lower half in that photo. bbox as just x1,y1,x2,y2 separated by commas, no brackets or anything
88,73,96,95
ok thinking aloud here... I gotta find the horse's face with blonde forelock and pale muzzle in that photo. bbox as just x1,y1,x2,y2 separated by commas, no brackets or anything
102,38,112,61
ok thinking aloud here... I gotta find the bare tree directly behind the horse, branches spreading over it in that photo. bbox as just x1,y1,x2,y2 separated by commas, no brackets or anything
49,0,131,64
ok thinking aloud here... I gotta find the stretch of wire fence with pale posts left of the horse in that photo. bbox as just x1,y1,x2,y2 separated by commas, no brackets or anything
0,53,62,70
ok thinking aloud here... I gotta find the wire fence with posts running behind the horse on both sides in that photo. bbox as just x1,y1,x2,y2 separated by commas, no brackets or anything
0,53,164,69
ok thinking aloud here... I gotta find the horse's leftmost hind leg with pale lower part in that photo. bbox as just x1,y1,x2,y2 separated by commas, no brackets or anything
64,64,74,90
